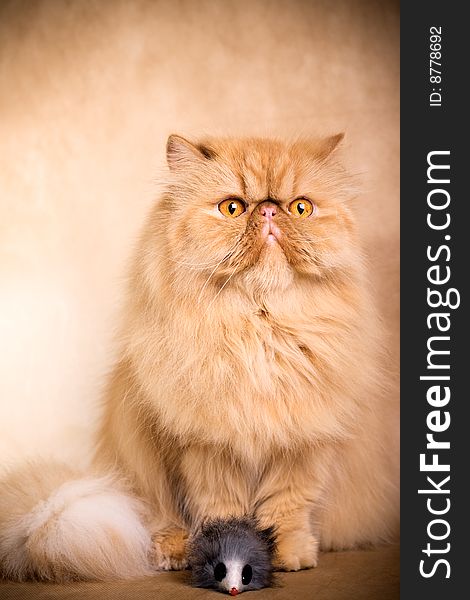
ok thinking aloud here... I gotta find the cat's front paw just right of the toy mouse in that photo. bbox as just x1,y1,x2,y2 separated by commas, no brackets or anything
274,532,318,571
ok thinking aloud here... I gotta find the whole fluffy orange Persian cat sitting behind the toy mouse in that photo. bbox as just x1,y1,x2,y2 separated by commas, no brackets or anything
0,135,398,580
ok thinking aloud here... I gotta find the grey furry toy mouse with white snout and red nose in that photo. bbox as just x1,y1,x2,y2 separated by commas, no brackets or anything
188,517,276,596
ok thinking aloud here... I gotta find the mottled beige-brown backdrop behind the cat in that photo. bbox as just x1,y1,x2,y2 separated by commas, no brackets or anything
0,0,399,465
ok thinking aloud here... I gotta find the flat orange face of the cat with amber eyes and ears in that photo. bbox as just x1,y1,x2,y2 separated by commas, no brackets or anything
162,135,356,296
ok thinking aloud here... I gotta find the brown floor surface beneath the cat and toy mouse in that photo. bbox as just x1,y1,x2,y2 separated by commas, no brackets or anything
0,546,399,600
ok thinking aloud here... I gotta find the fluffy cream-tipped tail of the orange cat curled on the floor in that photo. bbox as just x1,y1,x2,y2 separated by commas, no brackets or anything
0,463,154,581
